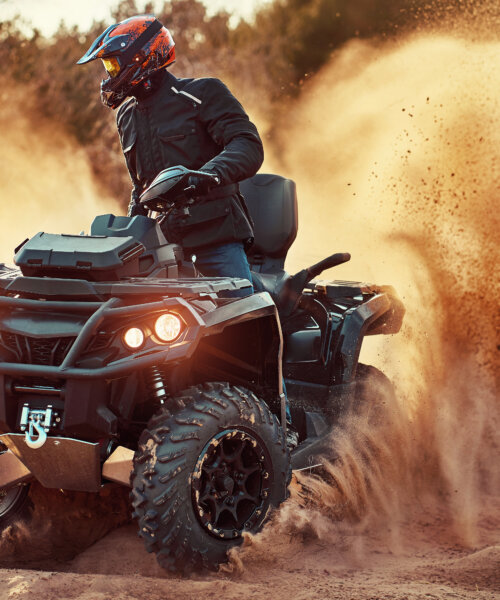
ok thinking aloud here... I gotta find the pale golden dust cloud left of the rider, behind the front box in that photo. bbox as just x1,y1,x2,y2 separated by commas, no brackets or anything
0,94,120,263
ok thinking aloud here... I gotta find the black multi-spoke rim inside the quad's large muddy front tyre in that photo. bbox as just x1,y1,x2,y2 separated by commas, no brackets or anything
192,429,272,539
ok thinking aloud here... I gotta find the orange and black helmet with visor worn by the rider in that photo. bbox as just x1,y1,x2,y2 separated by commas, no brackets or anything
77,15,175,108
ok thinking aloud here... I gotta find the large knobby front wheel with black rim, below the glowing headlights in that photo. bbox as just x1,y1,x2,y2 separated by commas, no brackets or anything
132,383,291,573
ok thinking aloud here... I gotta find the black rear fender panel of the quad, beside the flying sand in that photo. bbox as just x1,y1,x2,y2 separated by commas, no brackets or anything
282,281,404,390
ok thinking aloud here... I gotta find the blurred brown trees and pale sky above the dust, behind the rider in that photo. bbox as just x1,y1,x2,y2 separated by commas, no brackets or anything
0,0,499,216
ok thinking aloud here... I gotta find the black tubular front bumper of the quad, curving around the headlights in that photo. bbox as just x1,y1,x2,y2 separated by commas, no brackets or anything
0,297,204,441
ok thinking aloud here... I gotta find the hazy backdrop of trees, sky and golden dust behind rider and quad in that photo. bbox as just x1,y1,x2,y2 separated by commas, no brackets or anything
0,0,500,568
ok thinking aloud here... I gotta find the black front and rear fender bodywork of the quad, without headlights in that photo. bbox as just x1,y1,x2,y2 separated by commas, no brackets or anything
0,272,403,468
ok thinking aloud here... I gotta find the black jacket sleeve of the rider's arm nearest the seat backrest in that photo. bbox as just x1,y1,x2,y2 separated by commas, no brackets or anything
200,79,264,184
